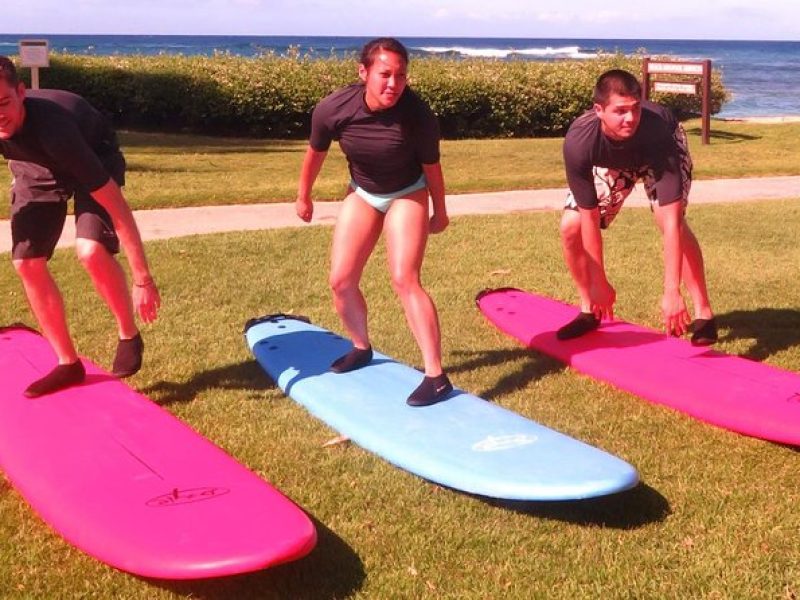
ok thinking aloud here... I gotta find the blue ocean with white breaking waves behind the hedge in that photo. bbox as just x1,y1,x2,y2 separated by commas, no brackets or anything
0,34,800,118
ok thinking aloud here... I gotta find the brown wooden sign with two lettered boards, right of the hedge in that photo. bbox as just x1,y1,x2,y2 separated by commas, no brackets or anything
642,57,711,144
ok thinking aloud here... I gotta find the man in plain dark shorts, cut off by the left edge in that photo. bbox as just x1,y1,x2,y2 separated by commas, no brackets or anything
0,56,160,397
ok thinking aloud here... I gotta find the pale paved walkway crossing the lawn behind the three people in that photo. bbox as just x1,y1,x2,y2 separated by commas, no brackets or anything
0,177,800,252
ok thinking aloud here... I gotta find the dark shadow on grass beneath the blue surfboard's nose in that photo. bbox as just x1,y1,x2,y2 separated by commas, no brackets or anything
483,483,672,529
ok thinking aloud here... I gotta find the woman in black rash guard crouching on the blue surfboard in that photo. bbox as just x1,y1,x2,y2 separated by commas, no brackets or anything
296,38,453,406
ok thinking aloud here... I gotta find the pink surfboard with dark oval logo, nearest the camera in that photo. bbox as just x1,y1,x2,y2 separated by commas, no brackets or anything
0,327,316,579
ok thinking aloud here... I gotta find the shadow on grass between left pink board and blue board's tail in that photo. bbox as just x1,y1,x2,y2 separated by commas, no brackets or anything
142,360,275,406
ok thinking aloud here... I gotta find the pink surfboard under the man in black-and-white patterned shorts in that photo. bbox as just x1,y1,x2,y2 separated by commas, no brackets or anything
476,288,800,445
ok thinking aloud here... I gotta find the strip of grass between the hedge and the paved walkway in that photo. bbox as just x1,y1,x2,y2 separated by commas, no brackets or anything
0,120,800,218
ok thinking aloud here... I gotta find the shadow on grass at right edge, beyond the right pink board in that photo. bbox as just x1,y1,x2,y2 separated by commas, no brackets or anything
716,308,800,361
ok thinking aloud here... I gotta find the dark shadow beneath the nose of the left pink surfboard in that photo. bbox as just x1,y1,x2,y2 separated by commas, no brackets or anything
146,519,366,600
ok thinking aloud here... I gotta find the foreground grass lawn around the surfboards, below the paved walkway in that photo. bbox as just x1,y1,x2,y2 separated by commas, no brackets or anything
0,199,800,599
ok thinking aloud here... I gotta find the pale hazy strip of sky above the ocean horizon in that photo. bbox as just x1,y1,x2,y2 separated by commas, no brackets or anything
0,0,800,41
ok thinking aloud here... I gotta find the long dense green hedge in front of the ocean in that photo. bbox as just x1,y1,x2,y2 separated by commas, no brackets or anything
28,54,728,138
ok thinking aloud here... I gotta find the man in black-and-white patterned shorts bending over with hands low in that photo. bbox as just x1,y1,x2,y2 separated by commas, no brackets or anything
557,70,717,345
